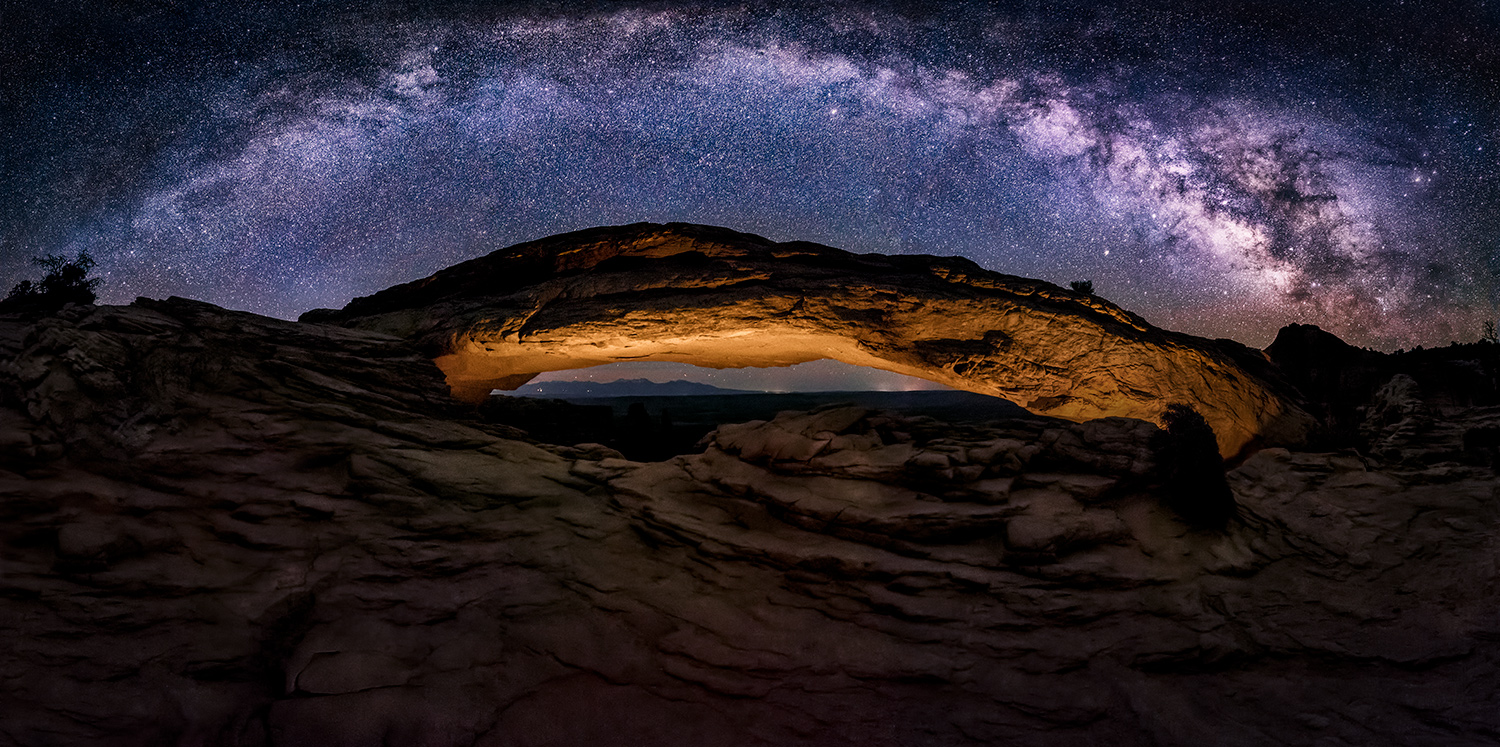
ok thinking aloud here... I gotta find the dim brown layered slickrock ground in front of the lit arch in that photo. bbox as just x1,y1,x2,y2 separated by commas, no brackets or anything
0,300,1500,746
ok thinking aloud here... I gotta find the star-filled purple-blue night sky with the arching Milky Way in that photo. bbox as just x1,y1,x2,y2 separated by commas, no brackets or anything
0,0,1500,350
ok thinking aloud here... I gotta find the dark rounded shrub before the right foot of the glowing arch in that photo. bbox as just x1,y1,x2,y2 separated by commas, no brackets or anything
1152,404,1235,530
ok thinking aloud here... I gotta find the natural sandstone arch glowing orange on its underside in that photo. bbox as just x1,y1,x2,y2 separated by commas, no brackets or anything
303,224,1311,456
